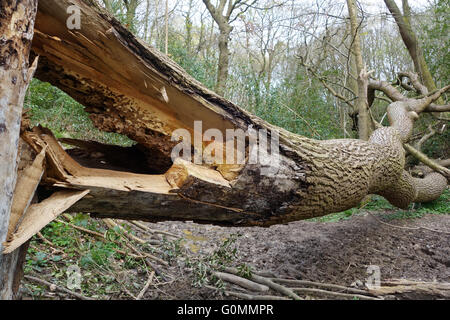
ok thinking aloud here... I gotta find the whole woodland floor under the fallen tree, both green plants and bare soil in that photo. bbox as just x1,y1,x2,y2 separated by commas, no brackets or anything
21,199,450,299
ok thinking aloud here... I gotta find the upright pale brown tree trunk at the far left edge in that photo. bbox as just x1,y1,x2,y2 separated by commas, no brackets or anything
0,0,37,299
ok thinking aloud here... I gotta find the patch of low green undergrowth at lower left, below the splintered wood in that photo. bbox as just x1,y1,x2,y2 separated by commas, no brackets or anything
22,214,151,299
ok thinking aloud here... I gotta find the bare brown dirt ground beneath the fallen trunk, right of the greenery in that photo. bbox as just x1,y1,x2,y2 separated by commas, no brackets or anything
140,212,450,299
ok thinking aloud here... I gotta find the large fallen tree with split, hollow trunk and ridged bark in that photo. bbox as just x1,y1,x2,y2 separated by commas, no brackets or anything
2,0,449,298
